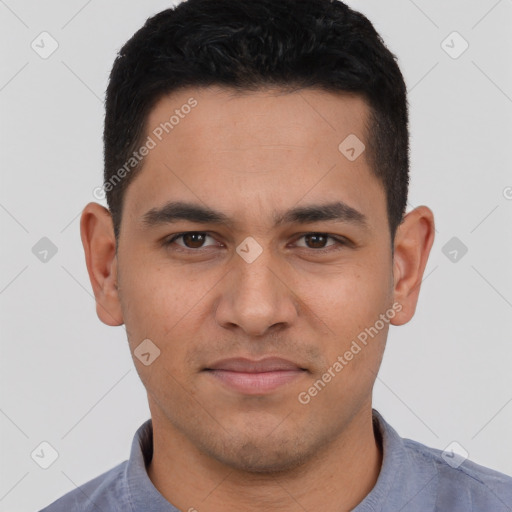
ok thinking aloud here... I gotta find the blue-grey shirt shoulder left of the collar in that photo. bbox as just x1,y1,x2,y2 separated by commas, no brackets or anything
40,461,131,512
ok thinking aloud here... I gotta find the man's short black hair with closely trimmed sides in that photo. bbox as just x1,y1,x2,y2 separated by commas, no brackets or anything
103,0,409,246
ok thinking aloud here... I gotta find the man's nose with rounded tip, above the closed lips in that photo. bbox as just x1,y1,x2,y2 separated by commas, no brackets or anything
215,249,299,336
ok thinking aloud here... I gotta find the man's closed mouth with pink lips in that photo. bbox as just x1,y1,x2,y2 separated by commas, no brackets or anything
203,357,308,395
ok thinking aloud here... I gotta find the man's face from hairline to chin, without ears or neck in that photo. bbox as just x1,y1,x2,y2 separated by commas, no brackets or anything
84,88,432,472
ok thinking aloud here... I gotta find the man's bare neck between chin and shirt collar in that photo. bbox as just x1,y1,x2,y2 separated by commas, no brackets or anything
147,405,382,512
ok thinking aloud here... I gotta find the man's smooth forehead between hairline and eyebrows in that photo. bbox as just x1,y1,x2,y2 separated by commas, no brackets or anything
120,87,385,234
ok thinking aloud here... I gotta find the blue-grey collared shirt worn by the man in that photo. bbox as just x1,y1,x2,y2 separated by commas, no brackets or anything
40,409,512,512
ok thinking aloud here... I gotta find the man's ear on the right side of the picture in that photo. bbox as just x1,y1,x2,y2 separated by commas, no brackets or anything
391,206,435,325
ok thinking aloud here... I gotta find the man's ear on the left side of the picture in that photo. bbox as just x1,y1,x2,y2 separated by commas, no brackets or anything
80,203,124,326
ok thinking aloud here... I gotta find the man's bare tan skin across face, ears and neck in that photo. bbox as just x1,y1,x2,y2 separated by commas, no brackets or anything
81,87,434,512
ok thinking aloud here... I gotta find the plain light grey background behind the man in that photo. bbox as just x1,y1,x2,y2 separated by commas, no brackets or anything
0,0,512,512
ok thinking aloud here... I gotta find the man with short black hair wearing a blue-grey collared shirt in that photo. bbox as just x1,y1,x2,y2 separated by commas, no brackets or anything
40,0,512,512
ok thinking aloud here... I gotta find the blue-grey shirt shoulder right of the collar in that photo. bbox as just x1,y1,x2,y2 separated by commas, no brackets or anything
404,439,512,512
